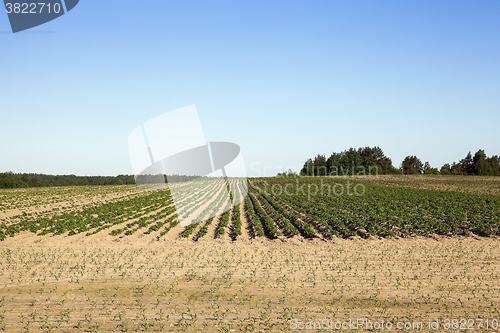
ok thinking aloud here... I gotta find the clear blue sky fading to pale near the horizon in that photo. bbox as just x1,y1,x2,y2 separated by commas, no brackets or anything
0,0,500,176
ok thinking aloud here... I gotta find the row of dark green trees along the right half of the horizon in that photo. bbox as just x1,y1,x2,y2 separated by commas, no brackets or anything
292,147,500,176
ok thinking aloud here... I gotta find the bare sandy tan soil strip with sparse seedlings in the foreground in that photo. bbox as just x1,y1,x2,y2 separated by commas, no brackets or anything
0,230,500,332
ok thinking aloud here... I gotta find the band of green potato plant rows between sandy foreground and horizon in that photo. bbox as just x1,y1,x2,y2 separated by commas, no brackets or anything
0,177,500,241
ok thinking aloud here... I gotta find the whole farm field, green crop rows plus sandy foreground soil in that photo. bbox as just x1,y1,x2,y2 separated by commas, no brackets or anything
0,176,500,332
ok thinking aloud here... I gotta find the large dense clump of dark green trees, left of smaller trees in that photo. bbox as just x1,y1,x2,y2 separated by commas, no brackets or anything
298,147,400,176
